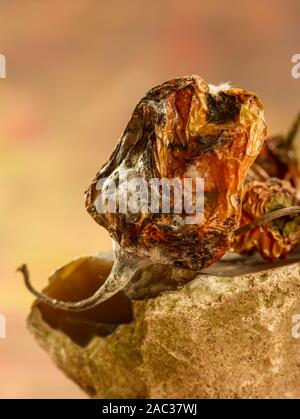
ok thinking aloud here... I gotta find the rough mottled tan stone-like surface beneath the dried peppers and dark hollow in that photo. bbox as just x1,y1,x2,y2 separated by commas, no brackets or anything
28,263,300,398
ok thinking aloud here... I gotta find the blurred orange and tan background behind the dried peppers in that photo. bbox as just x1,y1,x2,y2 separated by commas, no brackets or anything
0,0,300,398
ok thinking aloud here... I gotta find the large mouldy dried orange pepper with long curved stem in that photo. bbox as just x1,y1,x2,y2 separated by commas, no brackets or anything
19,76,266,310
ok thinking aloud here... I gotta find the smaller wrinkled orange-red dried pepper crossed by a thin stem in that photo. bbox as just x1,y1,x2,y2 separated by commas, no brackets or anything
232,178,300,261
